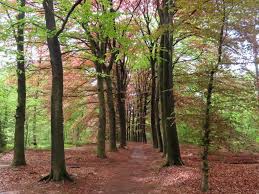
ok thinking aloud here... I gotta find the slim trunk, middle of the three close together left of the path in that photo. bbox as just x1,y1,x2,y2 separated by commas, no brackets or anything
105,71,117,152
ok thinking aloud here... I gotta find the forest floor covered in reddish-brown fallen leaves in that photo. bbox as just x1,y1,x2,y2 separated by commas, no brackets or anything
0,143,259,194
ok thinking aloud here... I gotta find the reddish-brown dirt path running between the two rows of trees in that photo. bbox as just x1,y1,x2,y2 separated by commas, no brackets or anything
104,145,159,194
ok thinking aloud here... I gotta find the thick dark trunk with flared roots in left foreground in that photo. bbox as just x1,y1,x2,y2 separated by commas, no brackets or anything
43,0,70,181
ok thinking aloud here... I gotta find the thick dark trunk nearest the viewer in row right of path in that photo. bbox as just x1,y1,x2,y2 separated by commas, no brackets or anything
160,0,183,166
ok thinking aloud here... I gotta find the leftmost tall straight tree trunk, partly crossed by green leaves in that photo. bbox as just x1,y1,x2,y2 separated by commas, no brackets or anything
12,0,26,166
